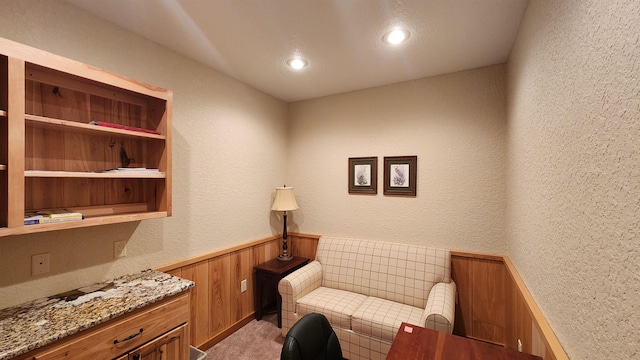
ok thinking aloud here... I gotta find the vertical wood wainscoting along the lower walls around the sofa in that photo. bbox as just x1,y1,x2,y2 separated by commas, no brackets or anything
157,233,568,360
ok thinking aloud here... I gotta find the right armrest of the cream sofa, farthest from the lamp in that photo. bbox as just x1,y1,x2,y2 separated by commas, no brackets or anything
421,281,456,334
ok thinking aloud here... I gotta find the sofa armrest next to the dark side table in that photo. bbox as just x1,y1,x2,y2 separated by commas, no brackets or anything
278,260,322,336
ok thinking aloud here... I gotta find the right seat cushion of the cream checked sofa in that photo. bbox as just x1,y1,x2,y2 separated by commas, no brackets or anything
351,297,424,341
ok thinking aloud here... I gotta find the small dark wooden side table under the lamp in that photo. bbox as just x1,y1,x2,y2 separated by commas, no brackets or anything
253,256,309,328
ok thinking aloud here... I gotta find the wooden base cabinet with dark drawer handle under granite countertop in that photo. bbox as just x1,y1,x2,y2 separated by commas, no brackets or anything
18,292,190,360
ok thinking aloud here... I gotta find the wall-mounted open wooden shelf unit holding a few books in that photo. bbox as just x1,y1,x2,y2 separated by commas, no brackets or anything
0,39,172,236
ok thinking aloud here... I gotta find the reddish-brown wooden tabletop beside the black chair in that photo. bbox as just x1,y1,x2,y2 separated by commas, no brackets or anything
387,323,542,360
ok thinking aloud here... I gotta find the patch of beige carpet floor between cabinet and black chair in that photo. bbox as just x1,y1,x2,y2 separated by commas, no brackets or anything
206,313,284,360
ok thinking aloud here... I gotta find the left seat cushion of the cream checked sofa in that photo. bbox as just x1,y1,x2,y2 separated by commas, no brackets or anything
296,286,367,329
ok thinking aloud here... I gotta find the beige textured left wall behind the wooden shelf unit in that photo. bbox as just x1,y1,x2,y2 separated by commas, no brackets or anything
0,0,288,308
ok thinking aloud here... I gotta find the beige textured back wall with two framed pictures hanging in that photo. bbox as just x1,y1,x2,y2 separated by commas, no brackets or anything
287,65,506,254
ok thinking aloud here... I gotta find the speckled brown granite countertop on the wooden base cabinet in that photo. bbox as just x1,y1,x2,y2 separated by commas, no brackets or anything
0,270,194,360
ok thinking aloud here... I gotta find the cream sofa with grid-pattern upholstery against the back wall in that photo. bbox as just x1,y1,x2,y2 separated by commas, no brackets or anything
278,236,456,360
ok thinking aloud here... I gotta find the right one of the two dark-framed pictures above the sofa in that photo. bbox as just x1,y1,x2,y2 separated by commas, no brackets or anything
384,156,418,196
